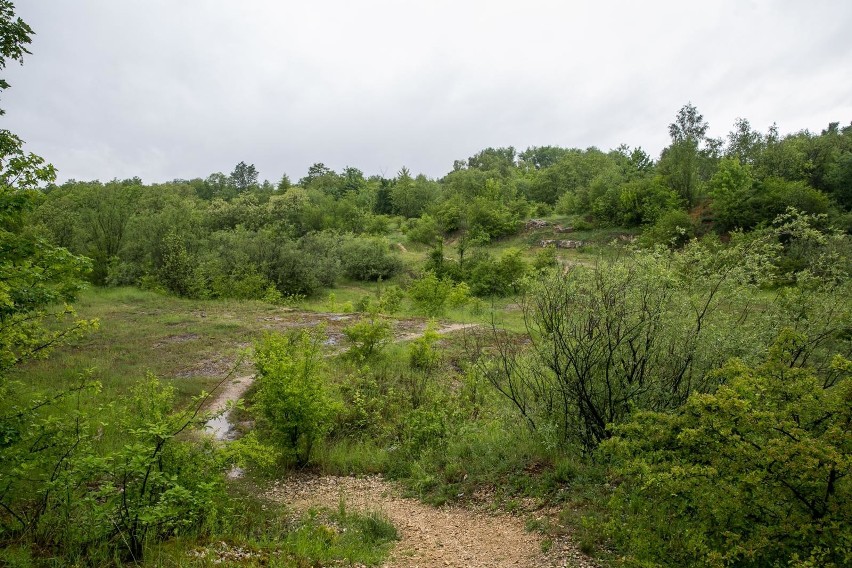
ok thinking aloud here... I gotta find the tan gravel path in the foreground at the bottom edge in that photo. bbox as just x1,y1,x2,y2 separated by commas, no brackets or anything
267,475,596,568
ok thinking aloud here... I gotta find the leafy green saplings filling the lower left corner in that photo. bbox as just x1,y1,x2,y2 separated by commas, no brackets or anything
0,377,224,561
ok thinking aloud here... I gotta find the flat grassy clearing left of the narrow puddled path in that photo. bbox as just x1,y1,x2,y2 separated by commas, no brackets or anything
11,288,288,401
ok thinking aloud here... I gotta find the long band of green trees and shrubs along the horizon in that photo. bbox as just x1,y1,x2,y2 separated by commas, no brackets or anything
31,104,852,304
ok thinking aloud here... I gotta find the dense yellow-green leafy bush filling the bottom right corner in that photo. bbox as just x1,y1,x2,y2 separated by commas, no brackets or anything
603,340,852,567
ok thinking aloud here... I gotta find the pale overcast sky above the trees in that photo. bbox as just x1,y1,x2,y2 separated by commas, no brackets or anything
0,0,852,183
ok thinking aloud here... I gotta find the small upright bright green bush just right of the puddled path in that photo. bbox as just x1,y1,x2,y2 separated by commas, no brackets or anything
254,331,334,465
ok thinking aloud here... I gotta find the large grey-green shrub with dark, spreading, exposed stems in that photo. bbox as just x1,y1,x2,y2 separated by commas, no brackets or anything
480,237,774,449
